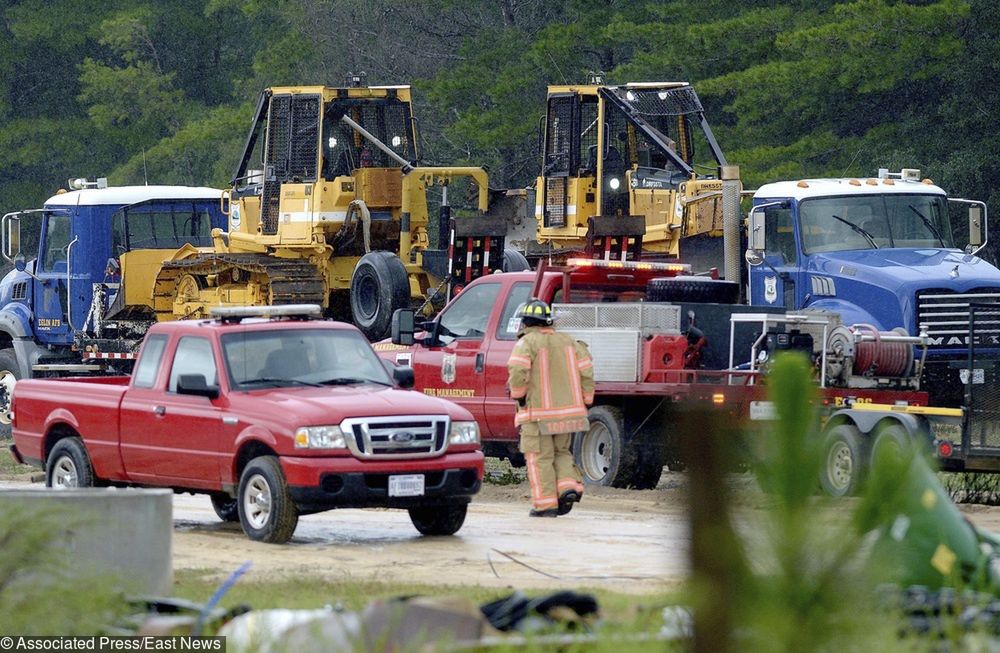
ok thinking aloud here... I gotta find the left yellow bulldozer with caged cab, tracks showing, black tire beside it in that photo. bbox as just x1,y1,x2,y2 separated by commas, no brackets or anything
153,75,527,339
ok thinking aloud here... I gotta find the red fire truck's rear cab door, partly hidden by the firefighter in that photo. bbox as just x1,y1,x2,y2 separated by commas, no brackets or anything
483,281,532,441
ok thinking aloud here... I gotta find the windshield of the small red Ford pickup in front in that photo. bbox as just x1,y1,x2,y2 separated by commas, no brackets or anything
222,329,392,390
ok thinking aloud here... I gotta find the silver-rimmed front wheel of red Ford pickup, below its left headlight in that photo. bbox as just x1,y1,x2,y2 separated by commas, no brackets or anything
237,456,299,544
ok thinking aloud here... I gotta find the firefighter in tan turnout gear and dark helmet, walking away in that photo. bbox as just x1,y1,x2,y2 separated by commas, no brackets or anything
507,299,594,517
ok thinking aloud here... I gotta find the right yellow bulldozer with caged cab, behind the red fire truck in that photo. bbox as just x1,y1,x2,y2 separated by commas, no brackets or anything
509,77,730,268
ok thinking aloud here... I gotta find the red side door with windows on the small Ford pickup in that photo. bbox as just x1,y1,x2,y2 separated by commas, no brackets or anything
121,336,223,489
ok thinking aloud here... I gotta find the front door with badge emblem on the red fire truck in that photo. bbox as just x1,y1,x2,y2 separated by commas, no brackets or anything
410,282,501,422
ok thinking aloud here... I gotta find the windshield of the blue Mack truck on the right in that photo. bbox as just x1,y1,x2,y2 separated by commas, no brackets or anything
799,195,955,254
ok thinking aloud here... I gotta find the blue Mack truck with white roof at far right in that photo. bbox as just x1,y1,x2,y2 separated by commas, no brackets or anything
745,169,1000,485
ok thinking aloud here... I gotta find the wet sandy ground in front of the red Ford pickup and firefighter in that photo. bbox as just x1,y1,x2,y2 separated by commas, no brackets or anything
173,476,688,593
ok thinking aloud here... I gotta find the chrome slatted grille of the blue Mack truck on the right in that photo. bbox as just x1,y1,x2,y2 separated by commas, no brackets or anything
917,288,1000,350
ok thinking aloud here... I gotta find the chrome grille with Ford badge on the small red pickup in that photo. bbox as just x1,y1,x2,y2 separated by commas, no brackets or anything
340,415,450,458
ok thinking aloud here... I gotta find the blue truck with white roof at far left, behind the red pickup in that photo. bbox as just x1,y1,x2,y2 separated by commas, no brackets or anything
0,179,227,437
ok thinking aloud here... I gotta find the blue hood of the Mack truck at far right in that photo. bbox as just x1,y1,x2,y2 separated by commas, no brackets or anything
810,248,1000,294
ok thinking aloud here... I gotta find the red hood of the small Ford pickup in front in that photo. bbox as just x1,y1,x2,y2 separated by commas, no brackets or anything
241,384,472,426
